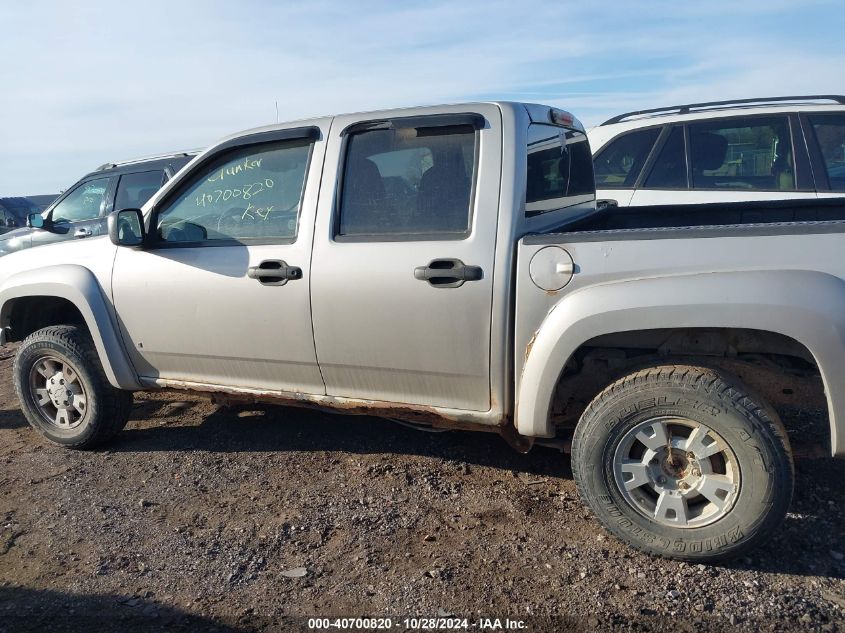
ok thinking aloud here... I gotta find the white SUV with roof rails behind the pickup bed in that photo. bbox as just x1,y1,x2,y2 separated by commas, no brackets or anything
588,95,845,206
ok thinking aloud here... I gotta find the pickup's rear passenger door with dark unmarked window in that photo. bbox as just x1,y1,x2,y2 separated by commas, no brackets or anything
311,106,502,411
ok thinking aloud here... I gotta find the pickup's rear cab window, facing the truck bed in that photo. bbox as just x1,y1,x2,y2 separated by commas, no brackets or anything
525,123,596,217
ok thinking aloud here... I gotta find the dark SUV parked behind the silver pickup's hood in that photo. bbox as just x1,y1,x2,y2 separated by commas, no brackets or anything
0,151,198,255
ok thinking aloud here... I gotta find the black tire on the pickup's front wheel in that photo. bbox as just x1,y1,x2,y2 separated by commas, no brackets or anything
13,325,132,449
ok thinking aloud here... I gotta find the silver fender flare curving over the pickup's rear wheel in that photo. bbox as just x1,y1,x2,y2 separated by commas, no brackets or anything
516,271,845,455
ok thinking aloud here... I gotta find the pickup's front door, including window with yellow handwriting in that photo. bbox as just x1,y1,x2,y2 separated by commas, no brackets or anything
113,121,329,394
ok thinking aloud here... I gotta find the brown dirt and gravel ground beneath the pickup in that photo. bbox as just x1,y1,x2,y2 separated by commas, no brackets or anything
0,349,845,632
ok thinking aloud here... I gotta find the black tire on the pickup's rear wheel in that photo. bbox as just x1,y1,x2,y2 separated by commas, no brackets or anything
572,366,794,562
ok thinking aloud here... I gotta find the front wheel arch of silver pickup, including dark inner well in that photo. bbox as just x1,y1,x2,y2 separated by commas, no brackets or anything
0,264,141,390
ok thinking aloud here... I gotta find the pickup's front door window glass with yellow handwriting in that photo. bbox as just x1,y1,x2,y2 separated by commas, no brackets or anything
158,139,312,242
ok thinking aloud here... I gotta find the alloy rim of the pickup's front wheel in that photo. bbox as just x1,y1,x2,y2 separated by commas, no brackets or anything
29,356,88,431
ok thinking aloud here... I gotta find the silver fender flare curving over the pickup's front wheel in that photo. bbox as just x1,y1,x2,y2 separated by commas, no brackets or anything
0,264,142,391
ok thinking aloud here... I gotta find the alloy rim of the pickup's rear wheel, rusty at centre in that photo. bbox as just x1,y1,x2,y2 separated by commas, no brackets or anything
613,416,740,528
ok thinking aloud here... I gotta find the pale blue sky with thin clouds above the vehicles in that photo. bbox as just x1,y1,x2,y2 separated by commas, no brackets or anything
0,0,845,196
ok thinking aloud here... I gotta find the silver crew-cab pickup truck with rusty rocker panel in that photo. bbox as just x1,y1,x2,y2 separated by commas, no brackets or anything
0,103,845,560
